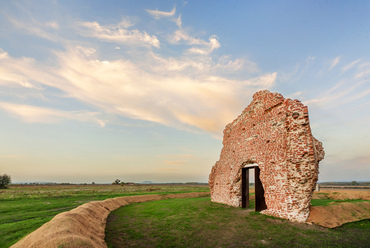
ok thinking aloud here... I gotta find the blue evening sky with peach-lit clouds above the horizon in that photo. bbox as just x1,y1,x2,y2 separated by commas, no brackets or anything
0,0,370,183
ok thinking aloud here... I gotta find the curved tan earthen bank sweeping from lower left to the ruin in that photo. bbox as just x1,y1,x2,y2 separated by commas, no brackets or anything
11,192,209,248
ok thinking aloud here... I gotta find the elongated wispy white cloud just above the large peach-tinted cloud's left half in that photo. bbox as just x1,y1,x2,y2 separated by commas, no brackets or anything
78,20,160,48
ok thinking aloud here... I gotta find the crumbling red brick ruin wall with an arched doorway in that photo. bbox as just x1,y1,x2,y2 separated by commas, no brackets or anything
209,90,324,222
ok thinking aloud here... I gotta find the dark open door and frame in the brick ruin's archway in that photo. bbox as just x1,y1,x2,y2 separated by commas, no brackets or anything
242,165,267,211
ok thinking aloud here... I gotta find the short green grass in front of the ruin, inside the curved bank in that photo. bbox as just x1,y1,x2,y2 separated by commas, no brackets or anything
106,197,370,248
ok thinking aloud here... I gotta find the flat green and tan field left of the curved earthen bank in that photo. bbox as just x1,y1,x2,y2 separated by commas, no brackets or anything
0,185,209,248
